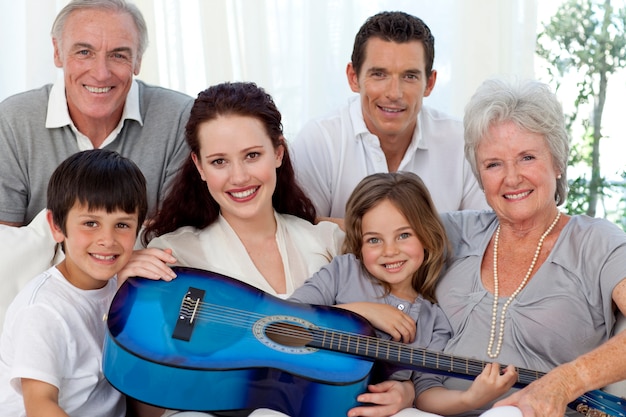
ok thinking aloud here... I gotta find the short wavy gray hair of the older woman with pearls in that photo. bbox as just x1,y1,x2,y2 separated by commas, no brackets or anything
463,78,569,205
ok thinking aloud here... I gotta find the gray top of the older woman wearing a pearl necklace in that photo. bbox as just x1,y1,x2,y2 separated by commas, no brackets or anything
437,211,626,416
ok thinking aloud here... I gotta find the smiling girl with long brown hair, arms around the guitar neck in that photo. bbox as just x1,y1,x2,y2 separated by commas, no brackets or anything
290,172,517,416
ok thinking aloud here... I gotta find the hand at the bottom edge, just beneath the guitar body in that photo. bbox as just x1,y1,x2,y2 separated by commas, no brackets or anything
348,381,415,417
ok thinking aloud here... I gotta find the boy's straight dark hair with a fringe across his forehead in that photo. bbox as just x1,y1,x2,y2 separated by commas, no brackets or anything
47,149,148,234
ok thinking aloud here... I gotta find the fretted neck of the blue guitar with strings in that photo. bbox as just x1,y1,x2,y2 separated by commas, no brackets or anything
307,329,544,387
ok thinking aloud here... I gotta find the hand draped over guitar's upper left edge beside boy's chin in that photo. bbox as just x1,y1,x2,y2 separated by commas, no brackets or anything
117,248,176,285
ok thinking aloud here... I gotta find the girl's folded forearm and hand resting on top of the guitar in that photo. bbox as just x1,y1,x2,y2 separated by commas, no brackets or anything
337,302,417,343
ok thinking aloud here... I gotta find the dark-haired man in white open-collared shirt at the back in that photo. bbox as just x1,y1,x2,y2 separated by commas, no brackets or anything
291,12,488,218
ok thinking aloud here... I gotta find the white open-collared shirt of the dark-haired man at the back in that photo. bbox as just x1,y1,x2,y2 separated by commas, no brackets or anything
291,96,489,218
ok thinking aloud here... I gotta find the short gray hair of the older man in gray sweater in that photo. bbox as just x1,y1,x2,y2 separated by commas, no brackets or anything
50,0,148,58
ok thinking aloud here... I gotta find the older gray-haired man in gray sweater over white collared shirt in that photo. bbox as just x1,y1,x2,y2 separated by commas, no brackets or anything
0,0,193,226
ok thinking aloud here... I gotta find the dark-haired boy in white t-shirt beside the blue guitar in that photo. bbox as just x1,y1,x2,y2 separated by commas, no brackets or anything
0,149,147,417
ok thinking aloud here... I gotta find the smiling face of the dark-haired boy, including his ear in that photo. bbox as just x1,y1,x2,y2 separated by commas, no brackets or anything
48,202,139,290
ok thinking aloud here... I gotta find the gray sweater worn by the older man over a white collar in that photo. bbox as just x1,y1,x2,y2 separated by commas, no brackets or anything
0,81,193,224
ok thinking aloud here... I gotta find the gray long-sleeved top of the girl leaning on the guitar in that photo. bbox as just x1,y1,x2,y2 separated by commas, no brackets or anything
289,254,450,395
